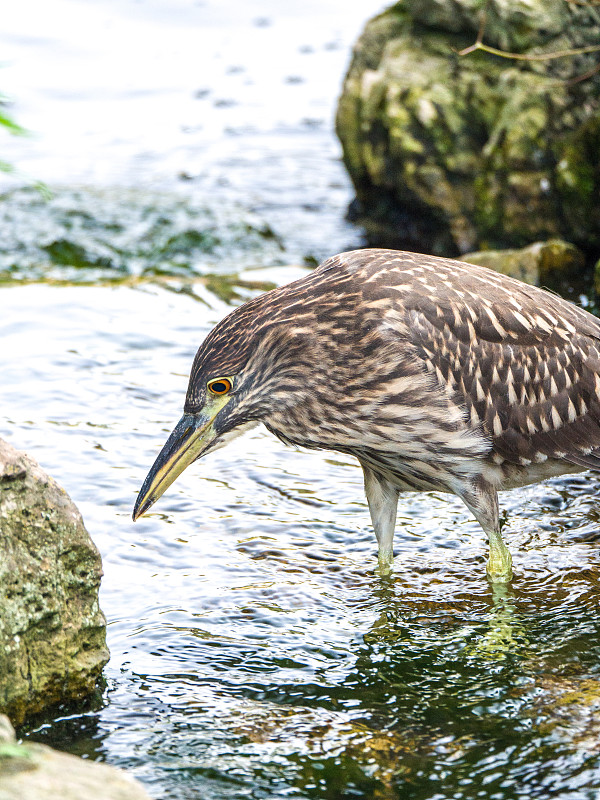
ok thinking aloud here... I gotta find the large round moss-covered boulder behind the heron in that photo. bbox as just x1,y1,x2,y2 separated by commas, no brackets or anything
336,0,600,255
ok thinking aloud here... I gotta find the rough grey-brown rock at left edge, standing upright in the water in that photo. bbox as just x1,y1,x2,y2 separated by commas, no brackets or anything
0,440,108,724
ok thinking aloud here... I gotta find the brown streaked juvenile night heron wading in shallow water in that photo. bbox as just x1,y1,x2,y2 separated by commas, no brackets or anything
133,249,600,581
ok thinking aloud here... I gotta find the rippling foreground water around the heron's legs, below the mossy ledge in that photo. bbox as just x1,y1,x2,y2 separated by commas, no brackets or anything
0,284,600,800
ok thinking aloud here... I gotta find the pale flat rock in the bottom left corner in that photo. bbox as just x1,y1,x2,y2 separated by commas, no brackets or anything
0,716,149,800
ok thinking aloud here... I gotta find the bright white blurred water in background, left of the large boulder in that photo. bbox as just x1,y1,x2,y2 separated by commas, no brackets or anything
0,0,385,260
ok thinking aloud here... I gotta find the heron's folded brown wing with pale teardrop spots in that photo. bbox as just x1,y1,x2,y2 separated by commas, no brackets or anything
396,273,600,470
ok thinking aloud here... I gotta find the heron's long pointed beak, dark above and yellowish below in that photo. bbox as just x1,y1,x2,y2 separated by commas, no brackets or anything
133,408,219,522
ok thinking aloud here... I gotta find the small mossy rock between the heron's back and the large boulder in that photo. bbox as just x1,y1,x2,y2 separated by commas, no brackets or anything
460,239,585,290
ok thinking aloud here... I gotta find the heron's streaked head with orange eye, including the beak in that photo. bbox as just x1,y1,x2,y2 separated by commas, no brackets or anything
133,293,314,520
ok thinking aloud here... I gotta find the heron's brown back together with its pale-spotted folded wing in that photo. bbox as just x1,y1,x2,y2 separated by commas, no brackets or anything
322,250,600,482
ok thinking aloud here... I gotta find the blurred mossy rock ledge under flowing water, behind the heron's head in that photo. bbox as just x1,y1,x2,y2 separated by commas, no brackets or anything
0,187,282,284
